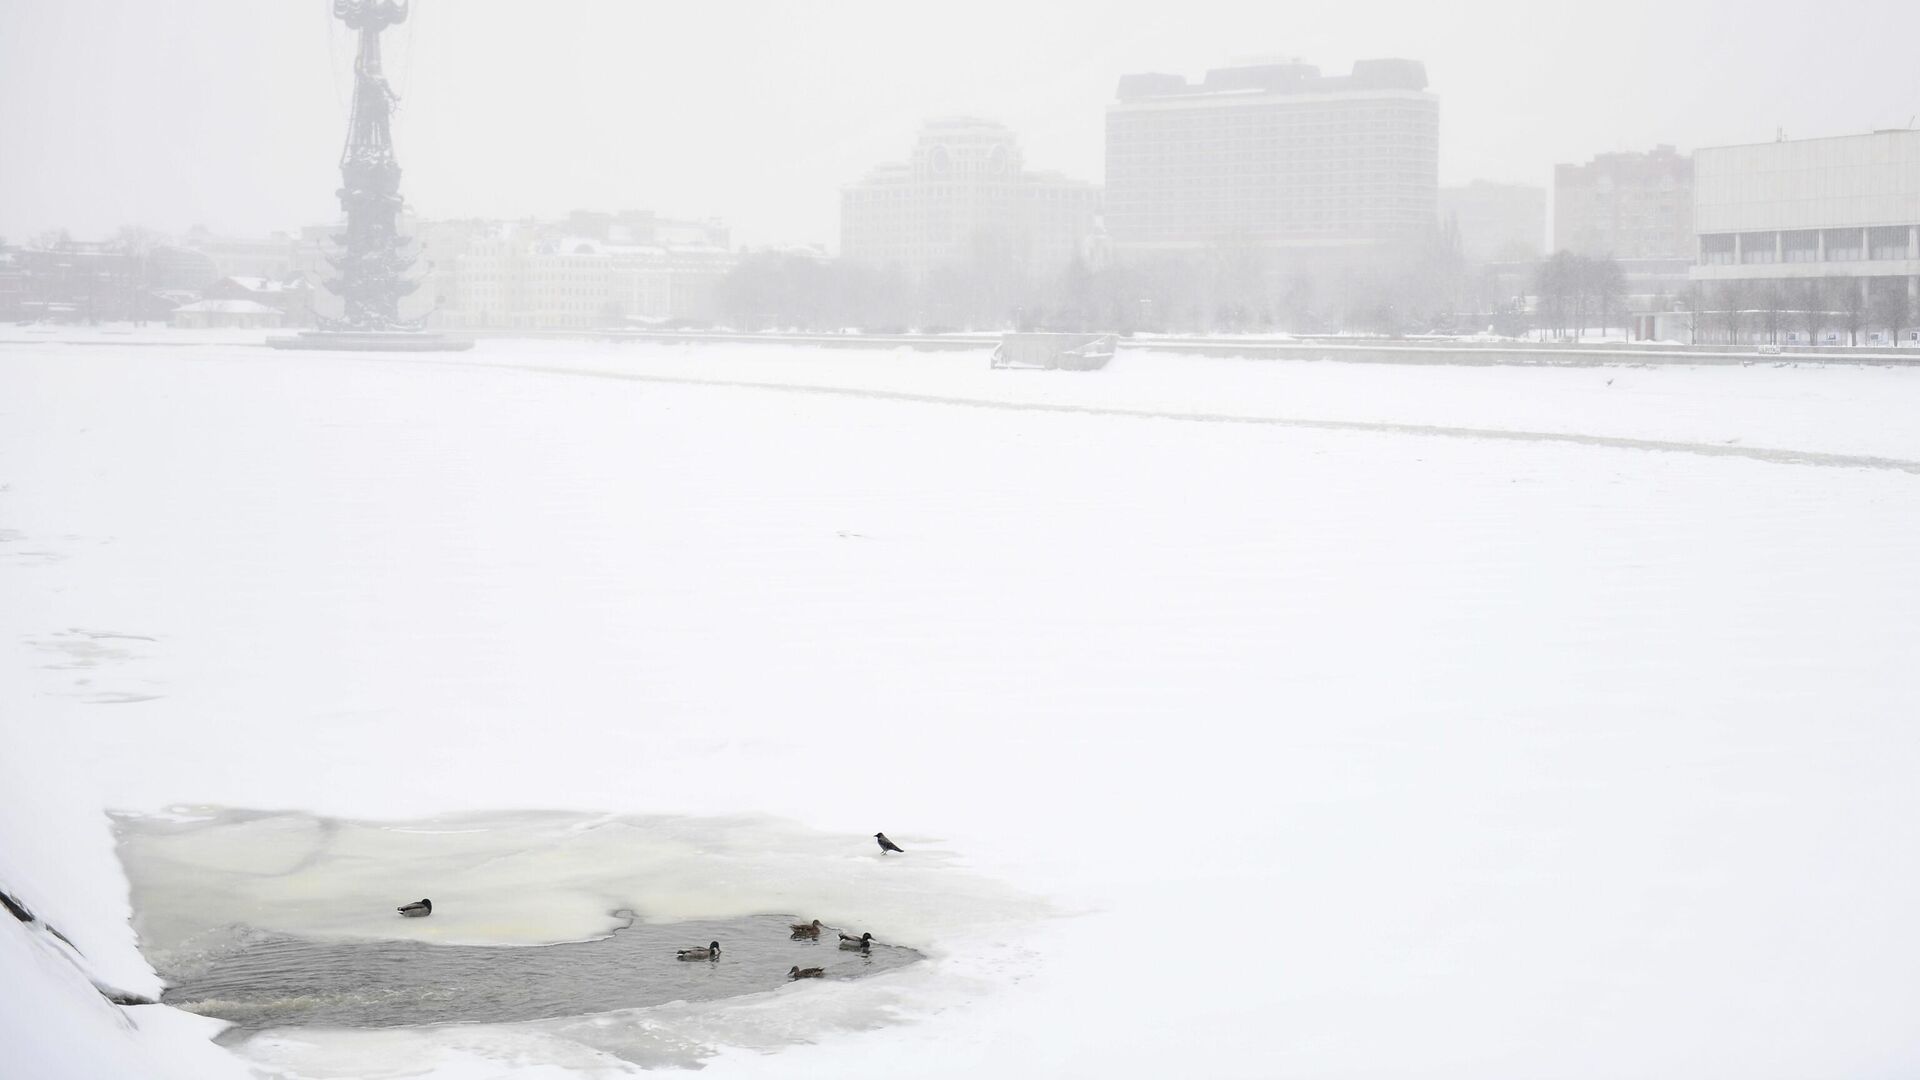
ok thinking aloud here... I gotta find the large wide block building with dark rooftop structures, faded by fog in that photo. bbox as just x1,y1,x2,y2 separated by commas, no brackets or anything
1106,60,1440,254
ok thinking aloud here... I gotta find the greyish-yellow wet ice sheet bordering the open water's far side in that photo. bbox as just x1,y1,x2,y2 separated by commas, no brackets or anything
117,807,1050,945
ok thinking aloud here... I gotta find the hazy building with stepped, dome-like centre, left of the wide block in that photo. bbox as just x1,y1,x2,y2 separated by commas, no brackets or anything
841,117,1100,279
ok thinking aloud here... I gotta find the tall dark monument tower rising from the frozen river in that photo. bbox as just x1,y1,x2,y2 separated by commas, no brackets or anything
326,0,420,331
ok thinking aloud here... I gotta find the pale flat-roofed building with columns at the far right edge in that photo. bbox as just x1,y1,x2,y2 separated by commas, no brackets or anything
1692,129,1920,344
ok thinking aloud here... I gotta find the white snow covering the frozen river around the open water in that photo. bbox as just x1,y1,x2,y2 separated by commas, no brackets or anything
0,334,1920,1078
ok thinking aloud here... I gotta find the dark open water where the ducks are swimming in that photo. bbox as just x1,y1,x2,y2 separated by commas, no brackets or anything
161,911,920,1030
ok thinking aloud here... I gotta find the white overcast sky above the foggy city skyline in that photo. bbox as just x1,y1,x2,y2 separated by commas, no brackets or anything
0,0,1920,244
